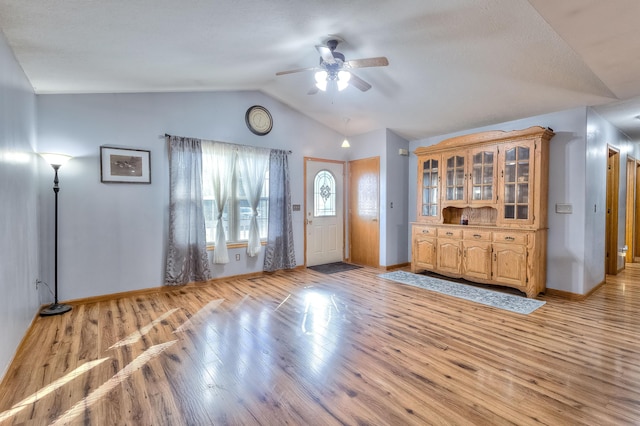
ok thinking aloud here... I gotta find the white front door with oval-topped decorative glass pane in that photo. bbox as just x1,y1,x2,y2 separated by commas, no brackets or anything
305,158,344,266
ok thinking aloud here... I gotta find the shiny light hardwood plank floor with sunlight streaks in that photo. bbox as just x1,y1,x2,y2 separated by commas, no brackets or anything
0,267,640,425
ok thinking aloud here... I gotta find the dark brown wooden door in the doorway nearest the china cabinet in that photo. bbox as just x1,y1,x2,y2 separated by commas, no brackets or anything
605,147,620,275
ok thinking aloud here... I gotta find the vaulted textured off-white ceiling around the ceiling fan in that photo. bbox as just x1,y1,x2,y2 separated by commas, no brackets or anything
0,0,640,140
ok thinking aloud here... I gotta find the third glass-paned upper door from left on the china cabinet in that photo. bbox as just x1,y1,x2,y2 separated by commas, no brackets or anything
469,148,498,203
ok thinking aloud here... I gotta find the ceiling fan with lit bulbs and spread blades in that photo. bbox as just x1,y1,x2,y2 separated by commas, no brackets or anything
276,38,389,95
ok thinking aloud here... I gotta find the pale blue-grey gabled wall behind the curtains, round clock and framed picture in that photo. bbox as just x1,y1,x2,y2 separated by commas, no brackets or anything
37,92,348,300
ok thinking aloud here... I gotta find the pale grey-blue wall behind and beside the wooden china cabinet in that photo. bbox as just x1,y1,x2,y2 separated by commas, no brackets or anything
409,108,592,294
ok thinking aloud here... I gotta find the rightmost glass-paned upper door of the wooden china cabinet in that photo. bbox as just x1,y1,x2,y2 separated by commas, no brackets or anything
503,145,532,221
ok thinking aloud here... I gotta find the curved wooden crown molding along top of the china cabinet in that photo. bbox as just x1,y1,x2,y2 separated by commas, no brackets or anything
414,126,555,155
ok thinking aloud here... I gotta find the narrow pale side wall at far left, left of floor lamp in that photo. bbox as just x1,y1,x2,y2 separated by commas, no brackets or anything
0,32,39,379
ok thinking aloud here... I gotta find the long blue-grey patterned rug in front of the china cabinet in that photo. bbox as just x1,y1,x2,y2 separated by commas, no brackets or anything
378,271,546,314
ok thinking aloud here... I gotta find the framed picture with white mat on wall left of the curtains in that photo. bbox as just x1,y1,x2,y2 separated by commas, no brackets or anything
100,146,151,183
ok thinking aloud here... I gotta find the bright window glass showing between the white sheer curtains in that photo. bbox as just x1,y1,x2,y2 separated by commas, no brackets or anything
202,144,269,245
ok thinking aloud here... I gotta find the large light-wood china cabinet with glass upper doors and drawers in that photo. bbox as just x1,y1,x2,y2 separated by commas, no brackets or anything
411,126,554,297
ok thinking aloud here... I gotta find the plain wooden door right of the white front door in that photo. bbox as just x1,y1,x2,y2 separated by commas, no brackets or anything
349,157,380,268
